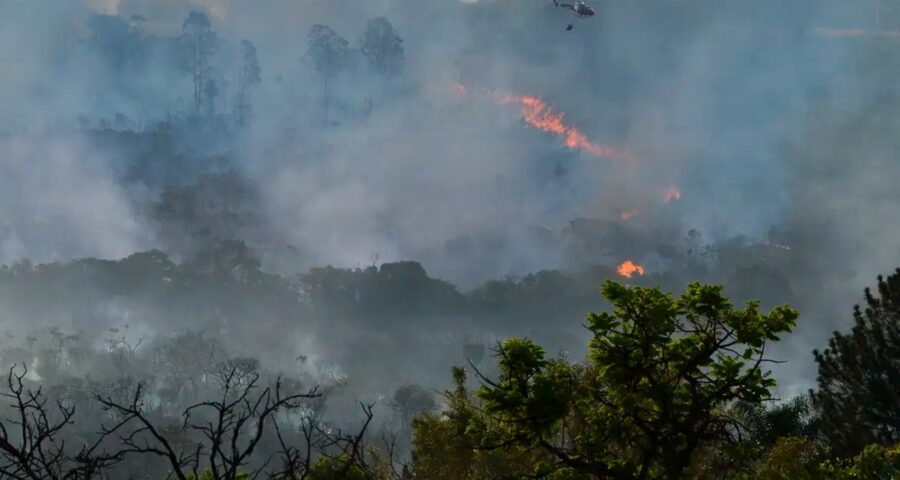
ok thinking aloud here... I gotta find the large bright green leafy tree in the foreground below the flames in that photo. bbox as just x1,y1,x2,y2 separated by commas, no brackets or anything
467,282,797,479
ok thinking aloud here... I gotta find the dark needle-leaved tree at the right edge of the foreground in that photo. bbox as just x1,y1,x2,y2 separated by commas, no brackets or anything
811,269,900,456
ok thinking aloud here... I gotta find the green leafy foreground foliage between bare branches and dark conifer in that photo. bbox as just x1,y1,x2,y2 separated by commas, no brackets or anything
413,282,900,480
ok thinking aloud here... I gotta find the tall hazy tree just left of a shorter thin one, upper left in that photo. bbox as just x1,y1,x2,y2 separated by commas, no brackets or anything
179,10,218,115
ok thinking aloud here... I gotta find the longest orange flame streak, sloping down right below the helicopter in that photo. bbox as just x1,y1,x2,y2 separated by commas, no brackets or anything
499,95,629,159
